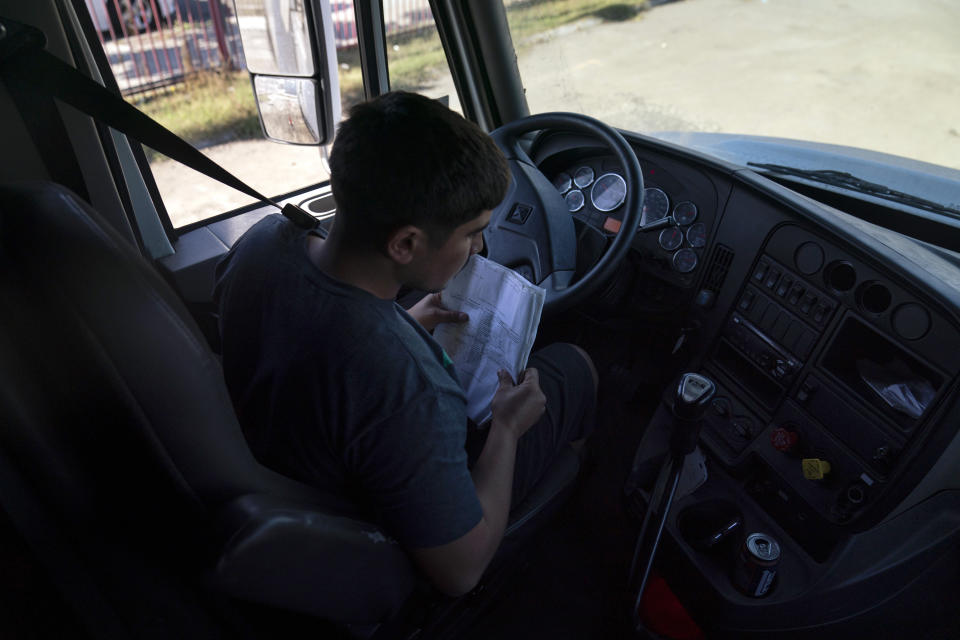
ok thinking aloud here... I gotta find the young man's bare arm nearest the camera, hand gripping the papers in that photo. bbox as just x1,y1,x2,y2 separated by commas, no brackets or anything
412,369,546,596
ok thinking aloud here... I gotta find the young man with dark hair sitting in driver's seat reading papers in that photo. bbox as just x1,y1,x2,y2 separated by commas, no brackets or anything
216,93,595,595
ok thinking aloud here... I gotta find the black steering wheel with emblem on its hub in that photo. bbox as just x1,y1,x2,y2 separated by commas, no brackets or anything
484,113,643,315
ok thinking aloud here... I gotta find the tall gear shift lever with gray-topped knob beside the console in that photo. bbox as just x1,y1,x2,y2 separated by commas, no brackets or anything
630,373,717,631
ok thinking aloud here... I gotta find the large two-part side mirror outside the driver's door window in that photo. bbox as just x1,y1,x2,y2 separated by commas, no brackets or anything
234,0,340,145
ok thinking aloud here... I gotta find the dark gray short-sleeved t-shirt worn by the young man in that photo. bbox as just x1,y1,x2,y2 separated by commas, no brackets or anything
215,215,482,548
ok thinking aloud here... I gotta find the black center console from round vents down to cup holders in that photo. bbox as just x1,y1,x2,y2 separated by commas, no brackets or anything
628,224,960,628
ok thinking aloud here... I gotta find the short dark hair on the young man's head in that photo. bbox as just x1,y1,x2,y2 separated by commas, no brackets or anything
330,91,510,251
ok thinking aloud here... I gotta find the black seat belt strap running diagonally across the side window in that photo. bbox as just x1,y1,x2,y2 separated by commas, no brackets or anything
0,19,318,228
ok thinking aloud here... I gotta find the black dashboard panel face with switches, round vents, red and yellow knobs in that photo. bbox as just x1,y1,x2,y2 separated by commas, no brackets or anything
705,224,960,544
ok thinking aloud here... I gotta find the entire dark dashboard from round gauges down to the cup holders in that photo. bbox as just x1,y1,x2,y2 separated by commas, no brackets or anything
531,134,960,626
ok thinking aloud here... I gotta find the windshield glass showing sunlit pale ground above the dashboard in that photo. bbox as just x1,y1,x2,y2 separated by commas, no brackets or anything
507,0,960,169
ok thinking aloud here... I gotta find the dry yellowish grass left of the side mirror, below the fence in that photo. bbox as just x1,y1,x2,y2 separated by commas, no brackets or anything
129,71,262,160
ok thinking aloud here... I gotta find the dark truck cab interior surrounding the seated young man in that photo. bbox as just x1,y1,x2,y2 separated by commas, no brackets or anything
0,0,960,638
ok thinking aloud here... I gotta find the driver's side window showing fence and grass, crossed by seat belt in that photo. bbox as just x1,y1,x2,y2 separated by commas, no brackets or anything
86,0,366,227
